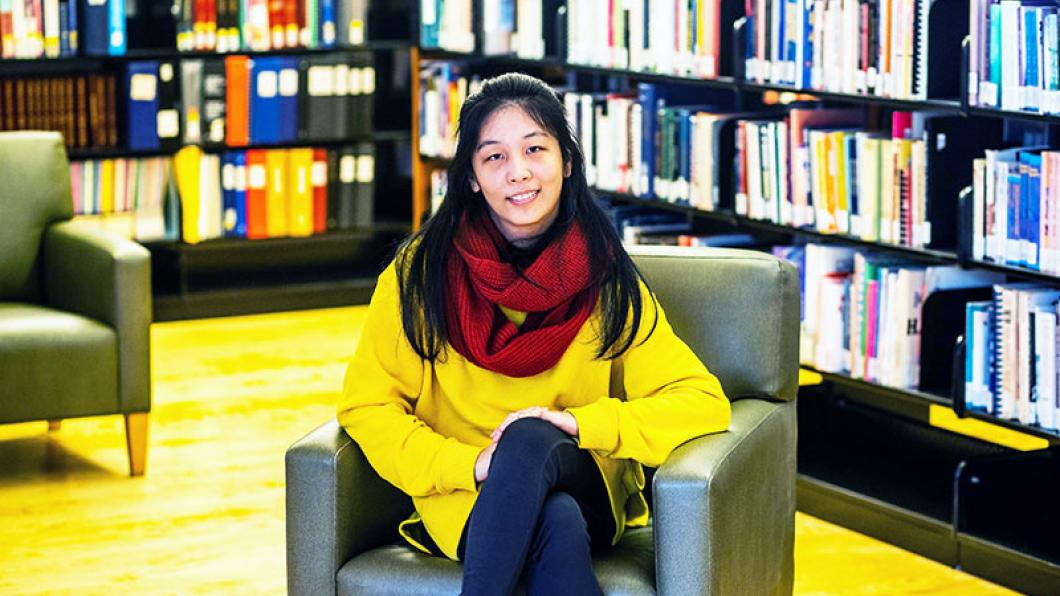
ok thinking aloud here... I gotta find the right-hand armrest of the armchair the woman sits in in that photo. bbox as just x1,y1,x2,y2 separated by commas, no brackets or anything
653,400,796,595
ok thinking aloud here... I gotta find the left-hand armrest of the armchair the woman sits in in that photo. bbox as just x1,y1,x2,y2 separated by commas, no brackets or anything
286,420,412,596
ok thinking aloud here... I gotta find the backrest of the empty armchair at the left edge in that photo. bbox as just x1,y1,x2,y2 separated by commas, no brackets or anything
0,132,73,302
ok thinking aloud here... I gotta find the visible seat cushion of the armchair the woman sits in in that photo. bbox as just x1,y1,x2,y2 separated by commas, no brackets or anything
337,527,655,596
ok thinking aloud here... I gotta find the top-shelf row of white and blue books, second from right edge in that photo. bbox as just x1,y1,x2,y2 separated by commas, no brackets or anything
745,0,931,100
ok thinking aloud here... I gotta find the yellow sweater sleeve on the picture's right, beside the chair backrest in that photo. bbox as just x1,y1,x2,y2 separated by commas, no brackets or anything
568,285,731,467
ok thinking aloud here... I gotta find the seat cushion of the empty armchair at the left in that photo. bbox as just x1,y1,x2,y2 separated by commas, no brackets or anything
0,302,119,422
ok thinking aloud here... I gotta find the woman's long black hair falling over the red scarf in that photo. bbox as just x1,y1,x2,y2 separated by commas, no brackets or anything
396,73,657,362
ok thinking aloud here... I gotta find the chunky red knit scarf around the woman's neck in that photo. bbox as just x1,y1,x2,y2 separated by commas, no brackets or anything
445,214,600,376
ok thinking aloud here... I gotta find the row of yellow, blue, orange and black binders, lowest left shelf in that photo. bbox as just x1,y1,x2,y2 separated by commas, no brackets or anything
173,143,375,244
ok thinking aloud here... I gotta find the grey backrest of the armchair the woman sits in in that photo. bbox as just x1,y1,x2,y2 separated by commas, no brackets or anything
630,246,799,400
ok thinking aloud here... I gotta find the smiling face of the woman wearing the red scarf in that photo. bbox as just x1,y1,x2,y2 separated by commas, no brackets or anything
471,106,570,246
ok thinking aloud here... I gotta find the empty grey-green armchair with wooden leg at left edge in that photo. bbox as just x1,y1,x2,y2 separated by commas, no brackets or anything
0,133,152,475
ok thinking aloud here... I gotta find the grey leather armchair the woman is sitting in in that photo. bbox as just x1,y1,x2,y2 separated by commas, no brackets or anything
286,243,799,596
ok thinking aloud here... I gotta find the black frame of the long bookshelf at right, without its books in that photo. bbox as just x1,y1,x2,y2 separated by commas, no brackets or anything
411,0,1060,593
